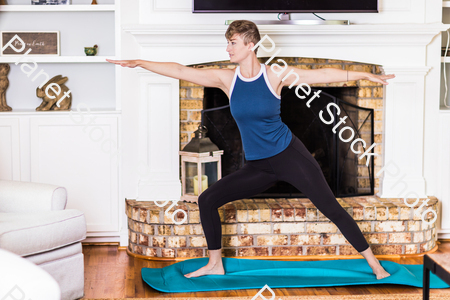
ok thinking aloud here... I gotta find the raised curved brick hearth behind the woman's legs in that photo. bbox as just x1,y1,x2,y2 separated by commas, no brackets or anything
126,196,440,259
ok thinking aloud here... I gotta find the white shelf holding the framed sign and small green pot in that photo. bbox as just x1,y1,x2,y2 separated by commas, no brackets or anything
0,55,117,64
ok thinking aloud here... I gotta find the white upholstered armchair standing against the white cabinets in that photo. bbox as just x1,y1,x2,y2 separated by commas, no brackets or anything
0,180,86,300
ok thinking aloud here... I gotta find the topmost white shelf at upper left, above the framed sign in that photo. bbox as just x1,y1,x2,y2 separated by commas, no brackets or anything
0,4,116,12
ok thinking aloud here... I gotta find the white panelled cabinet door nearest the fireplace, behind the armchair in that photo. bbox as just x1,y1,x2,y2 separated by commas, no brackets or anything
30,114,119,232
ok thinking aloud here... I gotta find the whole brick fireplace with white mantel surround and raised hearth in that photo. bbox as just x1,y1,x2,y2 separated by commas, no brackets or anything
126,24,441,259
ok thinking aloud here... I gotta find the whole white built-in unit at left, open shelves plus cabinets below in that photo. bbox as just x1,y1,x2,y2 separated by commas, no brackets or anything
0,0,123,242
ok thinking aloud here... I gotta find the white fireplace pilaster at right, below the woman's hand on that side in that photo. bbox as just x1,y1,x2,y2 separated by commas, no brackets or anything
379,66,430,198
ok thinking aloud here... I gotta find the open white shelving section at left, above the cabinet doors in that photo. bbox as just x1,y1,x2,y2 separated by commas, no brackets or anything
0,0,120,110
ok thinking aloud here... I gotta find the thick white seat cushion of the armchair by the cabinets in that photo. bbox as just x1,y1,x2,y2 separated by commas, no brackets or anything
0,209,86,256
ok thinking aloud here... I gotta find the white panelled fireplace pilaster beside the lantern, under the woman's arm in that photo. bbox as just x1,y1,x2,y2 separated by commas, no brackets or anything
137,71,181,200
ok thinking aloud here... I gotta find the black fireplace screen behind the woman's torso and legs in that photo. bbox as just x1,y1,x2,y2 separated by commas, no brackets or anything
202,87,374,198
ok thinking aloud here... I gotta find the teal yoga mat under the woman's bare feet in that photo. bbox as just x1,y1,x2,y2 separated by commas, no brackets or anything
141,257,450,293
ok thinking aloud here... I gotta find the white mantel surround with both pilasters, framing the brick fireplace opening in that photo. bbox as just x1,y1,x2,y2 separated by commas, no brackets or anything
123,23,447,203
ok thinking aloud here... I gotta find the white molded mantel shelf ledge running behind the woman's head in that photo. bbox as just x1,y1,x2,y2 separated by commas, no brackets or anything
122,23,450,47
